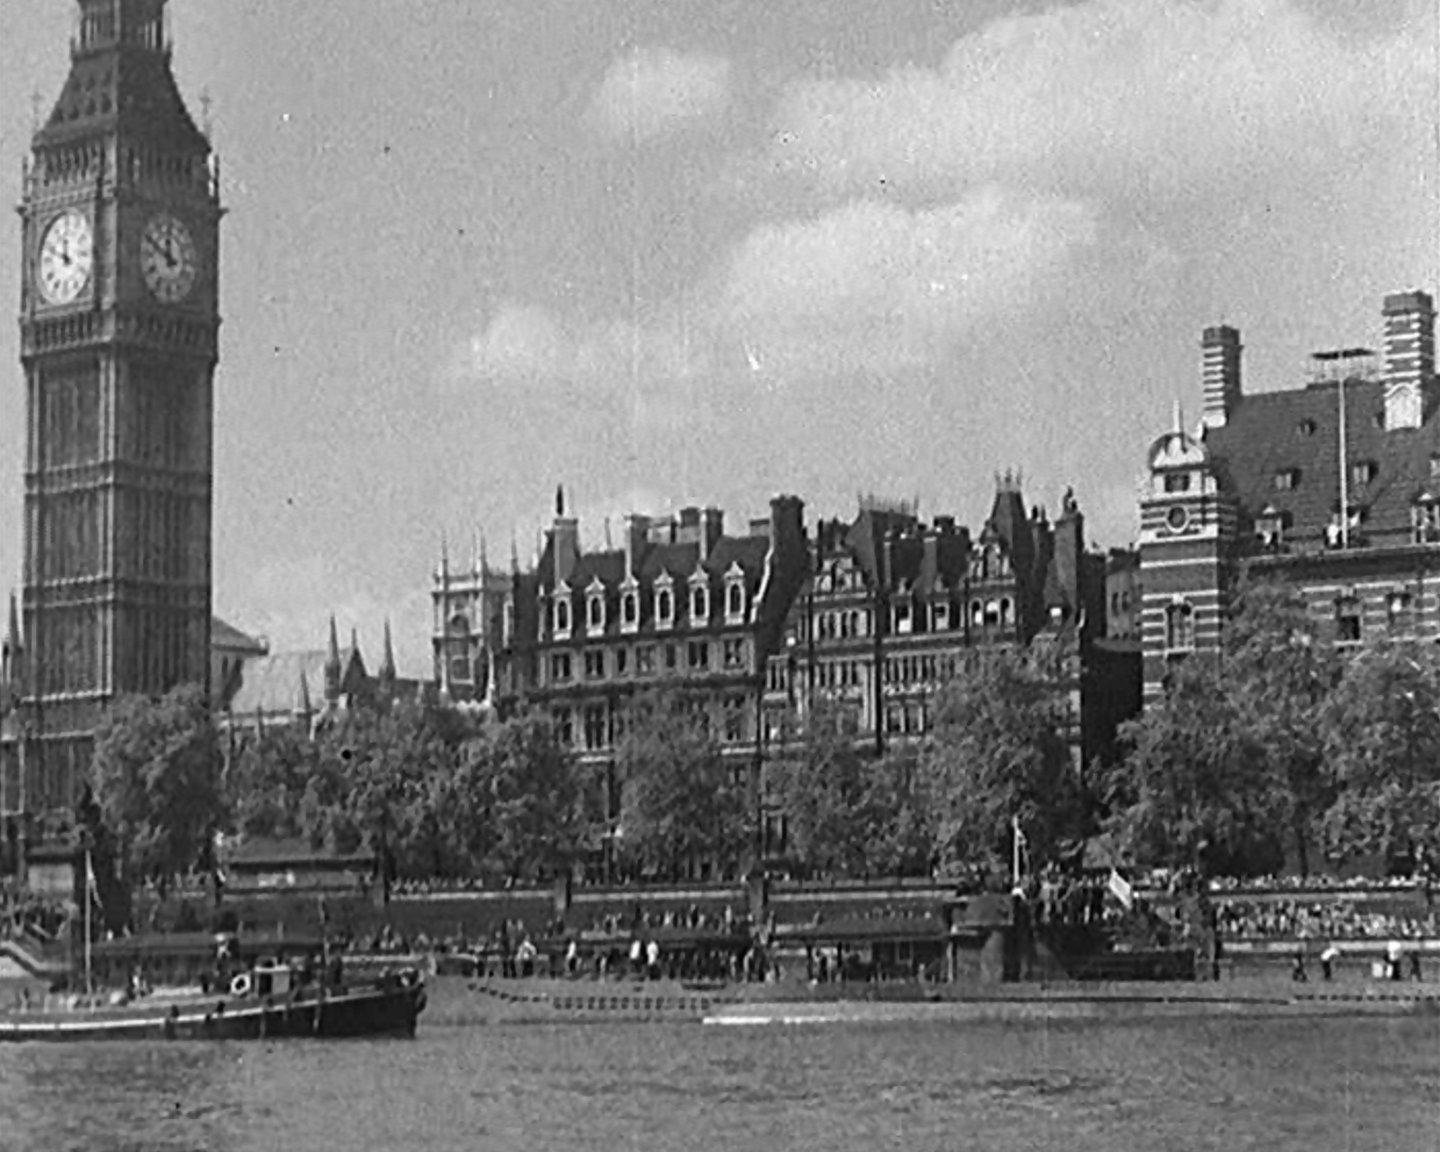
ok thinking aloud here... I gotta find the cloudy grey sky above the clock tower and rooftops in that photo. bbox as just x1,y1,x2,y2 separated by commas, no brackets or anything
0,0,1440,671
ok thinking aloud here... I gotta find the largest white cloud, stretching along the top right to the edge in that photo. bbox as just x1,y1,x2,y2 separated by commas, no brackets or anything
762,0,1433,199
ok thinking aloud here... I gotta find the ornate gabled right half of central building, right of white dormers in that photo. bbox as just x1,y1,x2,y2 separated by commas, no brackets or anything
765,474,1139,765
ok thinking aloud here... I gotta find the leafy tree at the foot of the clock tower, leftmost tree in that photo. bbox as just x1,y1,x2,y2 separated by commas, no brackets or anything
91,685,225,896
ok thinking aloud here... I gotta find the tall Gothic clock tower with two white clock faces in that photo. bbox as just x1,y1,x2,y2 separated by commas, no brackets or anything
7,0,222,816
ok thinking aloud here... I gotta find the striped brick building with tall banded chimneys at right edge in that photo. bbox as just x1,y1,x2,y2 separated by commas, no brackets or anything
1140,292,1440,698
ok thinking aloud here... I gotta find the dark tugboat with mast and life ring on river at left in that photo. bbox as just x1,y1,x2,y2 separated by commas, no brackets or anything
0,933,426,1043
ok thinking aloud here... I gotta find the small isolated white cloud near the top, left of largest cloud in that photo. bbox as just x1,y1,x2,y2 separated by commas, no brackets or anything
589,48,730,143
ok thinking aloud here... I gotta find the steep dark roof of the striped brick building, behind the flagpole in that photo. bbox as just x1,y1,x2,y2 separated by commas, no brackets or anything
1205,380,1440,541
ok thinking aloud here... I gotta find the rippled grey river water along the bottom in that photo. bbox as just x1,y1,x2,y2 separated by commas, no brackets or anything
0,1018,1440,1152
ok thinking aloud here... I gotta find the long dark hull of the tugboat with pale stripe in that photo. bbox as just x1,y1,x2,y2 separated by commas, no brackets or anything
0,984,426,1043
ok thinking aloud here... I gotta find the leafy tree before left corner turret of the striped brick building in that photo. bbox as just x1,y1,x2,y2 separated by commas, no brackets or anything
1107,658,1283,876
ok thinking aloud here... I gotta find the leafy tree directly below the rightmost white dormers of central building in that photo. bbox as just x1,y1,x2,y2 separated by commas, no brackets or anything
616,696,753,878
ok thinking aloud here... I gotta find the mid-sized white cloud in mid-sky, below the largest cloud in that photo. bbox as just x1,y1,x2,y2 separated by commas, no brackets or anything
717,187,1096,377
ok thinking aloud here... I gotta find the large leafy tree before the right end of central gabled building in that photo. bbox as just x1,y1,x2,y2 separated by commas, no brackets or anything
917,651,1087,871
